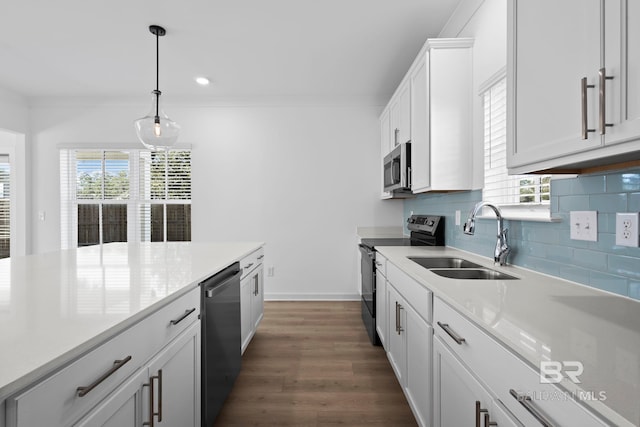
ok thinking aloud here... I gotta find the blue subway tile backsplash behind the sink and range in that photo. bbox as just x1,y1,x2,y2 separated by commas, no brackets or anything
404,168,640,300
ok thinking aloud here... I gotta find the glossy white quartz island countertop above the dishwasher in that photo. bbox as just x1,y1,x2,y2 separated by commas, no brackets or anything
0,242,262,403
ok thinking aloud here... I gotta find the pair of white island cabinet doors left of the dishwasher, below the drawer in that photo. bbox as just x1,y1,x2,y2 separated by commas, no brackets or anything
74,322,200,427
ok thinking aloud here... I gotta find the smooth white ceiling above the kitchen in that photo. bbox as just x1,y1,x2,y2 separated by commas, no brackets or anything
0,0,459,99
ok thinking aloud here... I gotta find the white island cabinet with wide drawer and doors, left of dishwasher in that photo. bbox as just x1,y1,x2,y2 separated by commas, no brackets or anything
5,288,200,427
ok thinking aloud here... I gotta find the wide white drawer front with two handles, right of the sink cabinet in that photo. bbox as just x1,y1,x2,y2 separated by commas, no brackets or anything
433,298,607,427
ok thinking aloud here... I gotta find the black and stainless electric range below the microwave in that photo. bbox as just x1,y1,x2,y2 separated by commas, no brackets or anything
359,215,444,345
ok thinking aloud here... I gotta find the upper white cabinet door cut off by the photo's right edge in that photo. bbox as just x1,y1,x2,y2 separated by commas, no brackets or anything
604,0,640,144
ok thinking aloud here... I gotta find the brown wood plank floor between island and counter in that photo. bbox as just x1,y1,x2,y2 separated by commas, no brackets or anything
215,301,416,427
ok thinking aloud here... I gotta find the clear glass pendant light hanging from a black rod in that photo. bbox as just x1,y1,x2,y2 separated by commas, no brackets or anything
134,25,180,150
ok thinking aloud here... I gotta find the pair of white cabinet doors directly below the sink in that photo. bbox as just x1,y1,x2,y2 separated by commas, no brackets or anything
387,279,433,426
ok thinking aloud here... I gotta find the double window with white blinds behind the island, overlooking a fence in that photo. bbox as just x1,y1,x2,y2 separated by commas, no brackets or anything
60,149,191,248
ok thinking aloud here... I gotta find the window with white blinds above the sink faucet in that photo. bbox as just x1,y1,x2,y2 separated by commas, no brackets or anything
481,71,551,219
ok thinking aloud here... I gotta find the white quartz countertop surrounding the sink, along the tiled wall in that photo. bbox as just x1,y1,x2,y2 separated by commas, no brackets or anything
376,246,640,426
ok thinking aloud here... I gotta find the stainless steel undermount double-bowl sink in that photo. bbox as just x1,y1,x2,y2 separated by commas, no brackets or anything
408,257,518,280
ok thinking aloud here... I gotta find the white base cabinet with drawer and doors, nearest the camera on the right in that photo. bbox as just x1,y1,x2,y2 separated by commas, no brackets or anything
433,298,607,427
